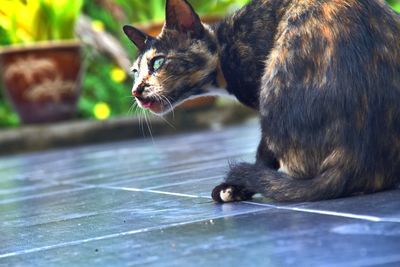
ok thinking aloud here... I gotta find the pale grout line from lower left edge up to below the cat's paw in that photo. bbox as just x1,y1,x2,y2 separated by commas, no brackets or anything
0,208,265,259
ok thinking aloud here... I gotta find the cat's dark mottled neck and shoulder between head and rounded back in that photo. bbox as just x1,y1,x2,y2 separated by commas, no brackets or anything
212,0,291,110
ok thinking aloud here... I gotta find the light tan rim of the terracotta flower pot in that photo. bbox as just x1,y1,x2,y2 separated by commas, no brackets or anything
0,40,82,55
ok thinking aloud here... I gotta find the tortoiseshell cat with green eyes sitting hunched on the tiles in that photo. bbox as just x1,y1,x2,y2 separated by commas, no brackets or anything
124,0,400,202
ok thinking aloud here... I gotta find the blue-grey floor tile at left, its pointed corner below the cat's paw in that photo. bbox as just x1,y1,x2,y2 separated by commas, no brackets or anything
0,188,268,254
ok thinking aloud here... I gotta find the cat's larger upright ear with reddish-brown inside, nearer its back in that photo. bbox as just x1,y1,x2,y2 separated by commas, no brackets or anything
164,0,204,37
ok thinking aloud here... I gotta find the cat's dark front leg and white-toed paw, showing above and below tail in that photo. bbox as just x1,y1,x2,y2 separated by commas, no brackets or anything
211,140,279,202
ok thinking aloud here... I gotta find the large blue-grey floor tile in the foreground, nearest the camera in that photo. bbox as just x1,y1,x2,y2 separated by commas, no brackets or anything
0,210,400,266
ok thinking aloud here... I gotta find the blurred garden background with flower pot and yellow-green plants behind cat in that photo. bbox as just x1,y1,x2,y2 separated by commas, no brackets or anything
0,0,400,153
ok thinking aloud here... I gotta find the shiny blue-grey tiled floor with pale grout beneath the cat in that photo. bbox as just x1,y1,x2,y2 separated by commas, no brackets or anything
0,122,400,267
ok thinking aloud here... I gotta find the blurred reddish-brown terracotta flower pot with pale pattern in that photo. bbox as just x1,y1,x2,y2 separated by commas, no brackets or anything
0,41,82,123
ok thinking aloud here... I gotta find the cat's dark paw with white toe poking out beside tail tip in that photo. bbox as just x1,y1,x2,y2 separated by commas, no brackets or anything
211,183,254,203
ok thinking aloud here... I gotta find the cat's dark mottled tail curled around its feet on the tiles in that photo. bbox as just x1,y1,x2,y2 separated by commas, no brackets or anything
214,163,348,202
